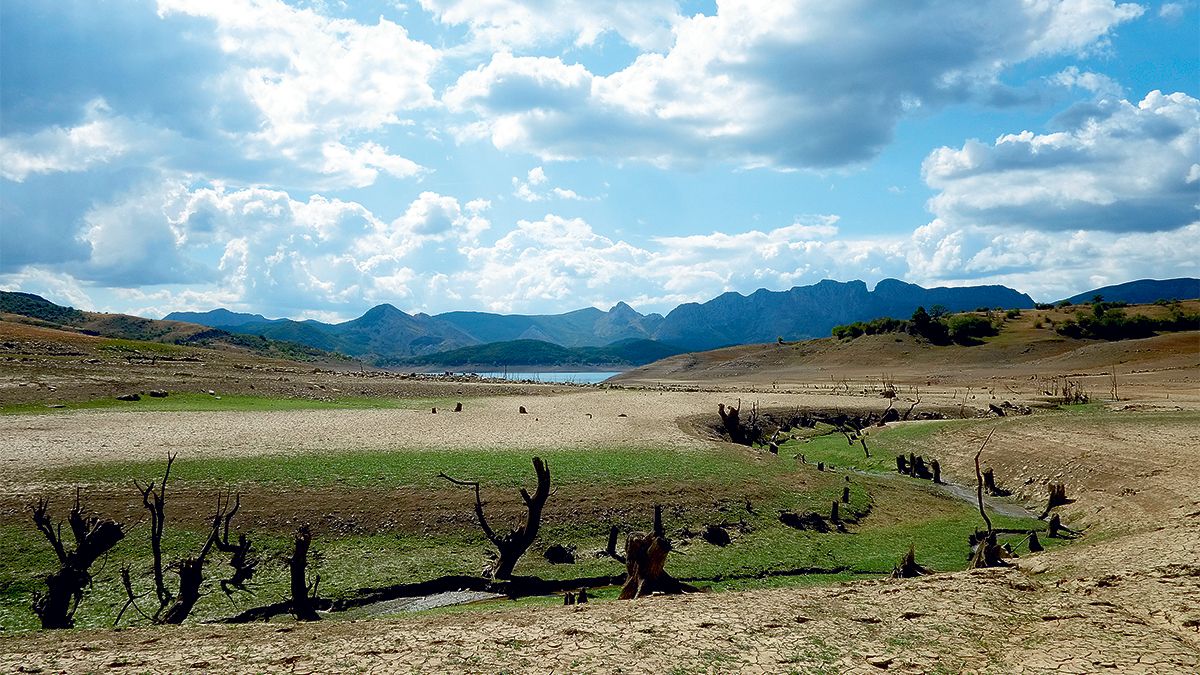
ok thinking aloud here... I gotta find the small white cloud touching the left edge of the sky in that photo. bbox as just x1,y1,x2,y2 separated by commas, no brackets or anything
0,98,142,183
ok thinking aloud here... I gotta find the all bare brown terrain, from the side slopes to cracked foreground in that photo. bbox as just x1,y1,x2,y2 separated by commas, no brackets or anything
0,312,1200,673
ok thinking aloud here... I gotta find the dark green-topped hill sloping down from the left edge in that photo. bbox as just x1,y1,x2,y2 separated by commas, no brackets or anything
0,291,347,362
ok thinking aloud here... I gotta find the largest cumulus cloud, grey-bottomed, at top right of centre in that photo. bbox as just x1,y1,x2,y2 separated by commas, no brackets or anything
443,0,1142,168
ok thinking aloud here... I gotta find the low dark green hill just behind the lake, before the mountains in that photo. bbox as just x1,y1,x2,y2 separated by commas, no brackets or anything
393,339,683,369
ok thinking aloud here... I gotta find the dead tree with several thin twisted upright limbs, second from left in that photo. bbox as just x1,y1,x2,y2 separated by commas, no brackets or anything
116,454,248,625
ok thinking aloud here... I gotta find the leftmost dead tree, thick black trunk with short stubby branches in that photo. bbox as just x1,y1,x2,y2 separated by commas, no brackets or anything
31,490,125,628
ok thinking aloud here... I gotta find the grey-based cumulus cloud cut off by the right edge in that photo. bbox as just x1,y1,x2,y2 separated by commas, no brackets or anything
922,91,1200,232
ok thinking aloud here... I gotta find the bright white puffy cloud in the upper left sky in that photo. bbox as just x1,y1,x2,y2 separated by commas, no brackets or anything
158,0,440,187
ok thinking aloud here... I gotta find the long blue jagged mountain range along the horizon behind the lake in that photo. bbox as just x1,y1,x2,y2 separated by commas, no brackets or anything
166,279,1051,364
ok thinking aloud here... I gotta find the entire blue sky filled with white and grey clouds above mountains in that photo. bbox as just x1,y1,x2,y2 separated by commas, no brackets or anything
0,0,1200,321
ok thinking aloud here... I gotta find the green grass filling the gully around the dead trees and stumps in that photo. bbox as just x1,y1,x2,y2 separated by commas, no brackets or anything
0,412,1075,629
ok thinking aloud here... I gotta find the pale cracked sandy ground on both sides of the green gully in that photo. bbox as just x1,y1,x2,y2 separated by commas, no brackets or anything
0,381,1200,673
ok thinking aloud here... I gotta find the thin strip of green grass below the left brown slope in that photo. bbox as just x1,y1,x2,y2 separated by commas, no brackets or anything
0,392,454,414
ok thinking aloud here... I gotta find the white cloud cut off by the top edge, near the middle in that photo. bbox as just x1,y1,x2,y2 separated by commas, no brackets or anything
420,0,682,50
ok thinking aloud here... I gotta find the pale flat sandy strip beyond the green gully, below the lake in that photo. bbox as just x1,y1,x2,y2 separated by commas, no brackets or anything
0,389,950,475
